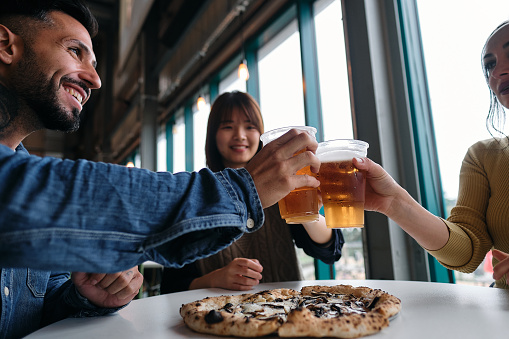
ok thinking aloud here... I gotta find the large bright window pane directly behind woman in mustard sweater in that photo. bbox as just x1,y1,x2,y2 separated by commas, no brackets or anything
417,0,509,285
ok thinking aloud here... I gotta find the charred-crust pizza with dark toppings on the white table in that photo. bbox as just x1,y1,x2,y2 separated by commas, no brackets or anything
180,285,401,338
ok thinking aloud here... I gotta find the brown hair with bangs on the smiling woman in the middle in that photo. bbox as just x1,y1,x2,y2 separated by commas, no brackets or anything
205,91,263,172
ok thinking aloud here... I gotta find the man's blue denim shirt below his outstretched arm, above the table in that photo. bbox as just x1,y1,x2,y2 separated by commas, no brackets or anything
0,268,120,339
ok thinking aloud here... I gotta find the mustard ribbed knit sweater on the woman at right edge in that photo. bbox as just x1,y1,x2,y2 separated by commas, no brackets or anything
429,138,509,288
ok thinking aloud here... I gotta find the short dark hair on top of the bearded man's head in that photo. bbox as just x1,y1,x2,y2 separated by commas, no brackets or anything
0,0,98,38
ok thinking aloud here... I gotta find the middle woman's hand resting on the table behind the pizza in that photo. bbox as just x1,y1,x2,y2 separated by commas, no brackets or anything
189,258,263,291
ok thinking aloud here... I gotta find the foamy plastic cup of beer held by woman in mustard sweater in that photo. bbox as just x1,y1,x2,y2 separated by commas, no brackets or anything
316,139,369,228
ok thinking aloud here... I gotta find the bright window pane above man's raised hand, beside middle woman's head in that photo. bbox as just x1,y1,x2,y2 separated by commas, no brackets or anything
258,21,305,131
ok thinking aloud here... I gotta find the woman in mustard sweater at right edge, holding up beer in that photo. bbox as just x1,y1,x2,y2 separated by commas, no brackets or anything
354,21,509,288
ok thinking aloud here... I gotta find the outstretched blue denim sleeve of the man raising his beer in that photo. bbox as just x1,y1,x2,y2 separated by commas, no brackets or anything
0,145,264,273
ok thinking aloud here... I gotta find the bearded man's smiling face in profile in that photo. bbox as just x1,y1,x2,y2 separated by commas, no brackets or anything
11,11,101,132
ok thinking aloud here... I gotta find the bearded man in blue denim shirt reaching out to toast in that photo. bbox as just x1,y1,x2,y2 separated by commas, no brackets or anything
0,0,320,338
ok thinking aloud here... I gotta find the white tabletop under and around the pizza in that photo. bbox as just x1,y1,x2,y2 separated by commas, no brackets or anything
28,280,509,339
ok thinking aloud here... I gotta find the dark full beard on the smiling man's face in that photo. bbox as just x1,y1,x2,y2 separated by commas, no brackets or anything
12,46,80,132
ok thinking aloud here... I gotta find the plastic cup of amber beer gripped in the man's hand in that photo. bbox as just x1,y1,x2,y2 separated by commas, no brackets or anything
260,126,320,224
